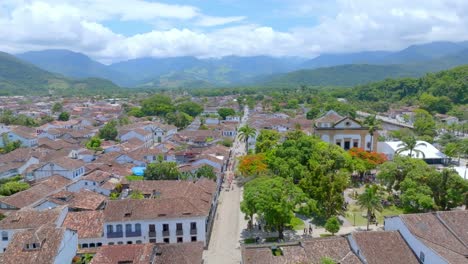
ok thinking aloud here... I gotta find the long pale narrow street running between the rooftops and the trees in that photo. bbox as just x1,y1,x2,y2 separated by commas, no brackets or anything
203,107,248,264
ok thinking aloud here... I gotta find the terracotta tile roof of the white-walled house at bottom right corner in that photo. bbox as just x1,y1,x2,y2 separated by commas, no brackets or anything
400,213,468,263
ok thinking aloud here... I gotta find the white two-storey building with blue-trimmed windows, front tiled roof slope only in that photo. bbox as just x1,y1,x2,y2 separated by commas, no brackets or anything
104,198,208,245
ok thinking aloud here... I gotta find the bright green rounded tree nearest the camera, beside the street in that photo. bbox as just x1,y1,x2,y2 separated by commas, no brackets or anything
241,177,307,239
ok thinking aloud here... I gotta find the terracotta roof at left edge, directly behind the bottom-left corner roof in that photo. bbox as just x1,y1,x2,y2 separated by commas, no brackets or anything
0,207,64,230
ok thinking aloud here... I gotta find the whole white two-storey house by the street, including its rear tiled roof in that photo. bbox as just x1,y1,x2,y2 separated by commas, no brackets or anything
96,180,216,245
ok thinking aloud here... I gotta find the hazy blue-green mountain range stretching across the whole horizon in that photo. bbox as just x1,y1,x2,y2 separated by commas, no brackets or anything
0,42,468,94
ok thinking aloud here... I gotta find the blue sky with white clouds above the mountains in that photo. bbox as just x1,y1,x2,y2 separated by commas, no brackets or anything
0,0,468,63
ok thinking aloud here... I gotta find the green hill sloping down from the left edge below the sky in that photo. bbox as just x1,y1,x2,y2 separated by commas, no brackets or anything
0,52,120,95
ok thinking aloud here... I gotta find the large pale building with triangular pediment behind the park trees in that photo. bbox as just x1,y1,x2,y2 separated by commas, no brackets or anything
314,110,378,151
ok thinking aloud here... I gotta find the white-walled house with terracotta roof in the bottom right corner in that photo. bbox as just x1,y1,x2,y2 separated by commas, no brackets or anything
384,210,468,264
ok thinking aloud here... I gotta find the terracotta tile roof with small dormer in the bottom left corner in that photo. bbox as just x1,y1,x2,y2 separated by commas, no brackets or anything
2,226,72,264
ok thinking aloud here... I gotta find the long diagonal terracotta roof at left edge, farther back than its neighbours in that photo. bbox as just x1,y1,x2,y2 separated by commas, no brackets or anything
0,175,71,208
